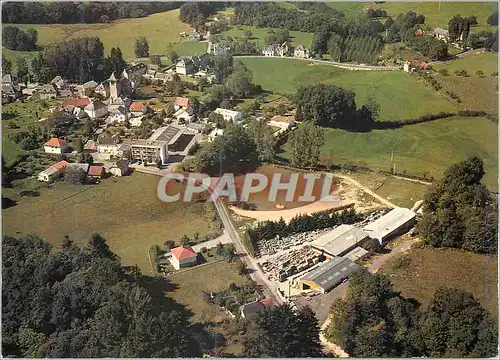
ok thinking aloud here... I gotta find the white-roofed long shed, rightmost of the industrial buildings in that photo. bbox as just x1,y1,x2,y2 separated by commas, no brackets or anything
363,207,416,245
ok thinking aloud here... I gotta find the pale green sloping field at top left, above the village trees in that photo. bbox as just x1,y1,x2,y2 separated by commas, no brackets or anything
4,10,195,58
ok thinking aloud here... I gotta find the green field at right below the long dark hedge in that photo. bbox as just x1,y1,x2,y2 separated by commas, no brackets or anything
312,117,498,189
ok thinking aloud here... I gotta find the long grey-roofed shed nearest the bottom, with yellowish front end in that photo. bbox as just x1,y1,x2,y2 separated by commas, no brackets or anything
300,257,359,293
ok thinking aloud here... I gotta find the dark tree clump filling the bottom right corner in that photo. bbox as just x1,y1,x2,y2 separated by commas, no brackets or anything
326,269,498,357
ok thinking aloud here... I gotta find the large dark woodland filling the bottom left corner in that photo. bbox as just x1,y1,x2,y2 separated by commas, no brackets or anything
2,234,201,358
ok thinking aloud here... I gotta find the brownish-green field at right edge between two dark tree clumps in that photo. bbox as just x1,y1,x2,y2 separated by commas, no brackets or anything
382,248,498,317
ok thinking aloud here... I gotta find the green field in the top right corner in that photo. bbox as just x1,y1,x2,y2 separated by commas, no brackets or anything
366,1,498,31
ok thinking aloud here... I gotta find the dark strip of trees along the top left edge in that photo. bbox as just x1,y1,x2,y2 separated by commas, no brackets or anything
2,1,182,24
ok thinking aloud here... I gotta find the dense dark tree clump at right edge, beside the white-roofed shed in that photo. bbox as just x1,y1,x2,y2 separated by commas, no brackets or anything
418,157,498,254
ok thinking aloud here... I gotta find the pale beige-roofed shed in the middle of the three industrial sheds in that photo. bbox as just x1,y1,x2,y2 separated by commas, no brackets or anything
311,224,369,257
